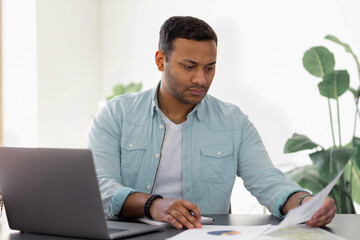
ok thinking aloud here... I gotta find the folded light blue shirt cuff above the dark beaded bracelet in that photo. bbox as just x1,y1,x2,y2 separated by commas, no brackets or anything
107,187,138,219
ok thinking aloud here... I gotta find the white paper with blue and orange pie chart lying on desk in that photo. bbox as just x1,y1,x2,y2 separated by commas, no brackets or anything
168,225,270,240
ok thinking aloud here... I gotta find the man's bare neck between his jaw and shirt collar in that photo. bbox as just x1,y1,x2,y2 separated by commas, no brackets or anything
157,86,195,124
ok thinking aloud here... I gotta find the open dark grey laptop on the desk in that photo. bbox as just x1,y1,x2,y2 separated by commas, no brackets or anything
0,147,163,239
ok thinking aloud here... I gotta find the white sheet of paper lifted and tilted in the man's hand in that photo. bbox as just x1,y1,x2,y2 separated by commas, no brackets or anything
266,170,344,233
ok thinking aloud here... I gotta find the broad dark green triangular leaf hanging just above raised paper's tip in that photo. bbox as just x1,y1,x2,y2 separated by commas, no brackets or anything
309,148,355,183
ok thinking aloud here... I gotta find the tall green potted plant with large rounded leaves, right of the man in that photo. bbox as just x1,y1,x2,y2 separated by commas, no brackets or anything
284,35,360,213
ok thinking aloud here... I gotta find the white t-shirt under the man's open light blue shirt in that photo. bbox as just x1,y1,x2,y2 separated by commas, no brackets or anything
152,112,185,199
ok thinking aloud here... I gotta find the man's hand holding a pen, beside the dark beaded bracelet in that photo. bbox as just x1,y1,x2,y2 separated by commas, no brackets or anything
150,199,201,229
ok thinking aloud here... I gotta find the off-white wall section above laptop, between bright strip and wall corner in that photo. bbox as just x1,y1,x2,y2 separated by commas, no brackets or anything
36,0,101,148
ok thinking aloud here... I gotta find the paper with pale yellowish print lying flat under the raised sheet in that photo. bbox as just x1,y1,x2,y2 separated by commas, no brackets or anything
256,224,345,240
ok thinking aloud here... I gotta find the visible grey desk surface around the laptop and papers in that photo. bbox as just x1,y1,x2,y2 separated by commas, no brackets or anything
0,214,360,240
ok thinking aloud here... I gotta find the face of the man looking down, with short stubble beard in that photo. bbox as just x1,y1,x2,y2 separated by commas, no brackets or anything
162,38,217,105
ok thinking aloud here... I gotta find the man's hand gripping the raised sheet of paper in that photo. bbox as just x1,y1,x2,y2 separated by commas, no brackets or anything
303,197,337,227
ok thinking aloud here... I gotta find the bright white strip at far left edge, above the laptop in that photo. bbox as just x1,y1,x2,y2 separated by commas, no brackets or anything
1,0,37,146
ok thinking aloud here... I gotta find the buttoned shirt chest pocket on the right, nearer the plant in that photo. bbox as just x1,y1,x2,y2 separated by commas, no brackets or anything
201,145,235,183
